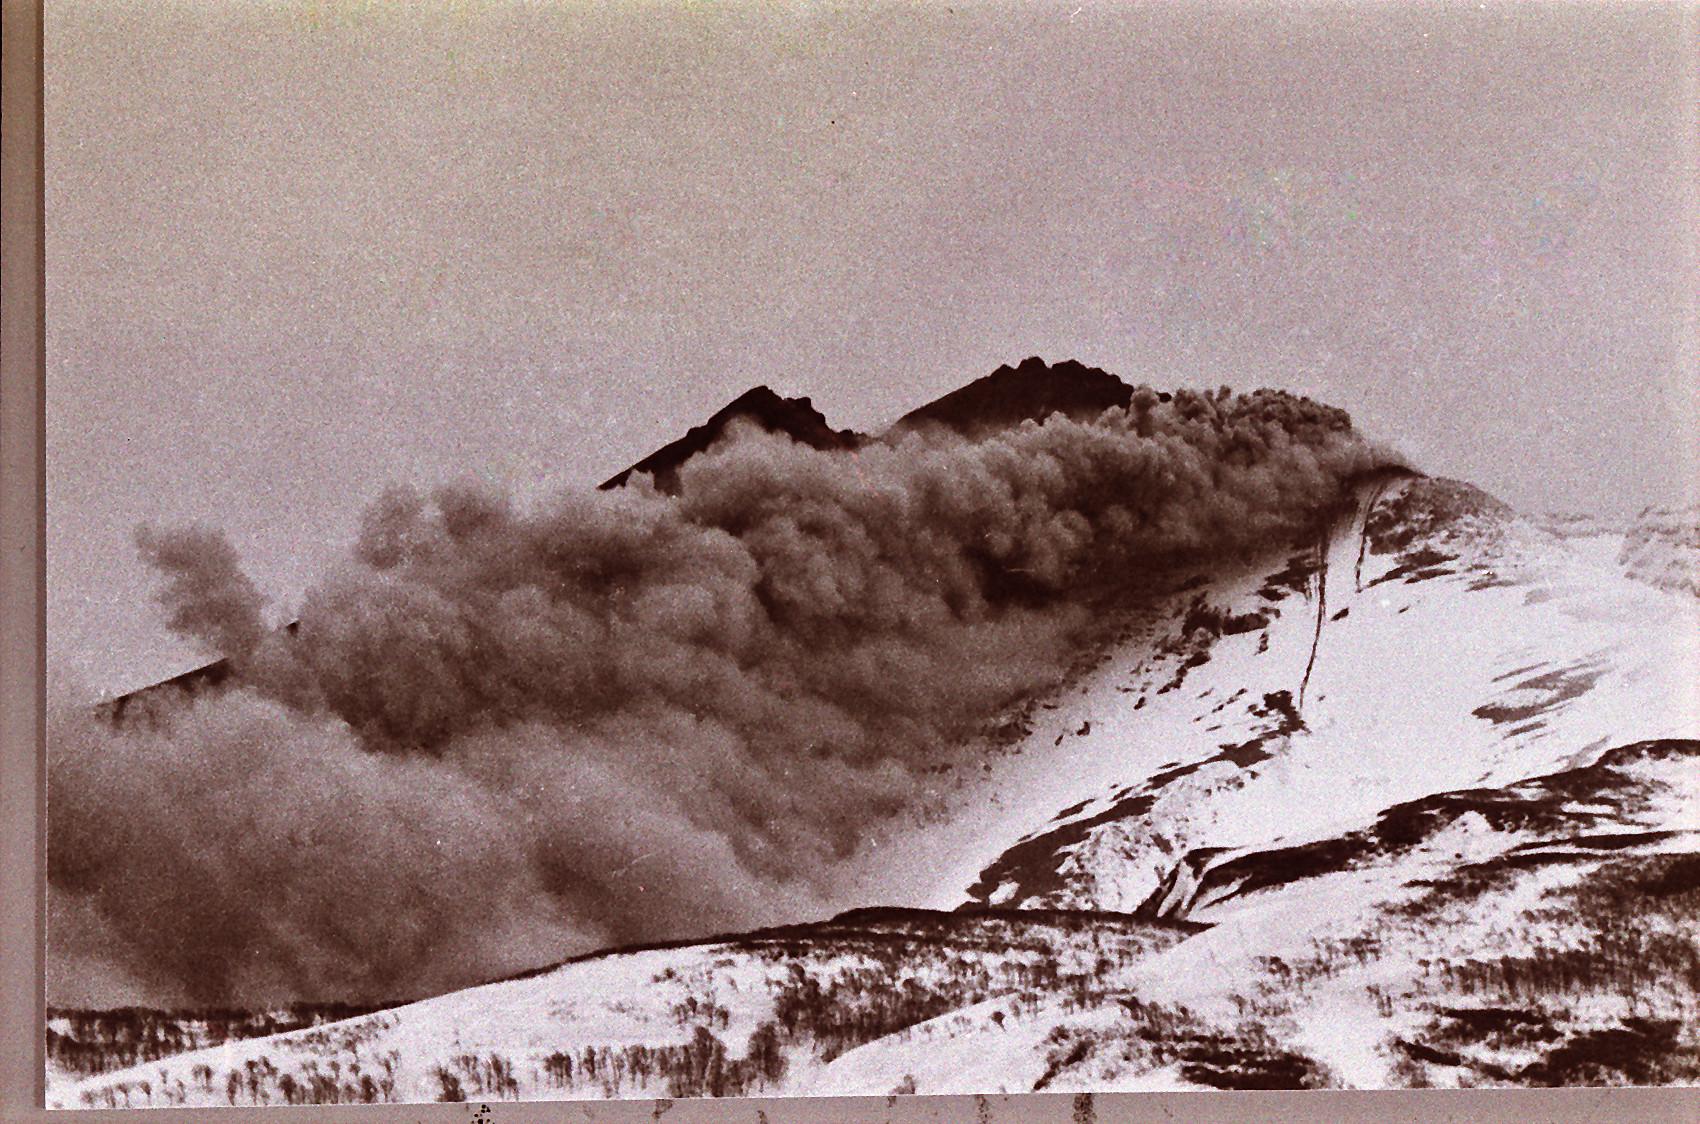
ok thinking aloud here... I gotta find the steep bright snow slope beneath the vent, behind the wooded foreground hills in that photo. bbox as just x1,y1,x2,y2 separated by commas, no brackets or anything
972,480,1700,910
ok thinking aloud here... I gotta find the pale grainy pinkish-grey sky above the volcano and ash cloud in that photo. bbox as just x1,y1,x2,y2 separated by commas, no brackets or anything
46,0,1700,692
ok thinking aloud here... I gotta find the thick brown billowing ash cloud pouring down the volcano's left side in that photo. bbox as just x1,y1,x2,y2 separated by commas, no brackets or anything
49,380,1400,1003
